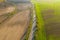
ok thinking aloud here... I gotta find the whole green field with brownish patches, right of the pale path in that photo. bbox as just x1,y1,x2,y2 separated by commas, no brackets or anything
33,2,60,40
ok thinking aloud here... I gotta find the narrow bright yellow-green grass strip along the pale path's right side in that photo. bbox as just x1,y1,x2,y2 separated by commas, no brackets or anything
32,1,46,40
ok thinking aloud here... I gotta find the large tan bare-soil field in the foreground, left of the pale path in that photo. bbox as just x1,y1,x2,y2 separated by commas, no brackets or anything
0,3,30,40
